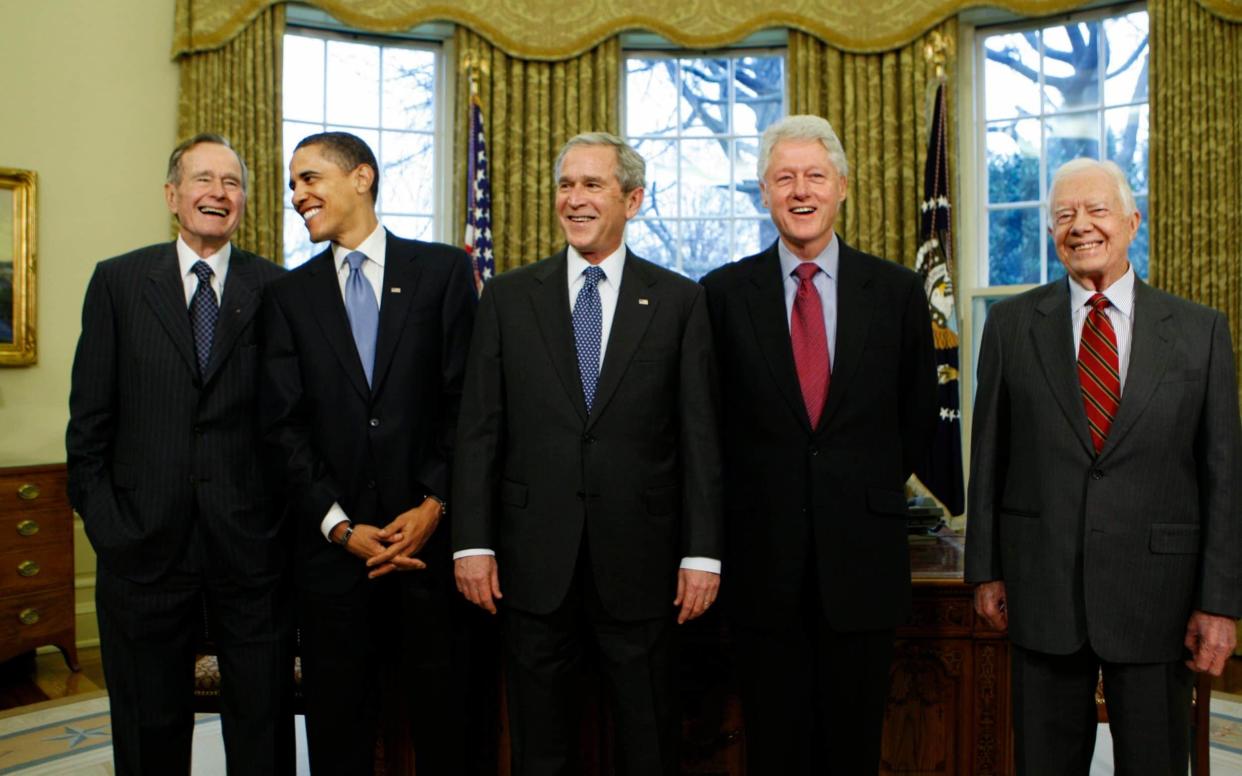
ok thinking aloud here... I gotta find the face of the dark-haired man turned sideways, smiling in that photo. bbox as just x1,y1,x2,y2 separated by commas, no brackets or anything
289,145,375,247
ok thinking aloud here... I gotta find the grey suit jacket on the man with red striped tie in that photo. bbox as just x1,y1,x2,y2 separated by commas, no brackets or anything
966,279,1242,663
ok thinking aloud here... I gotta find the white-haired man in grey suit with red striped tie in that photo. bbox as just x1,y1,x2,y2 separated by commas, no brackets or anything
966,159,1242,775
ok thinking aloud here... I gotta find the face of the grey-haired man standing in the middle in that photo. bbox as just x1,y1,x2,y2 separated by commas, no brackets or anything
556,145,642,263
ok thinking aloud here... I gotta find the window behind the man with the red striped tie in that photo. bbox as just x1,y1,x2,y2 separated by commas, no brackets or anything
955,5,1149,405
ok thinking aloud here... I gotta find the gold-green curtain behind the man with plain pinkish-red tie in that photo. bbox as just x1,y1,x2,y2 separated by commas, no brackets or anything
789,19,958,267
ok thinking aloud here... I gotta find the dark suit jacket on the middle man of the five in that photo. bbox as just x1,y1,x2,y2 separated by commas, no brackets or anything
453,244,722,621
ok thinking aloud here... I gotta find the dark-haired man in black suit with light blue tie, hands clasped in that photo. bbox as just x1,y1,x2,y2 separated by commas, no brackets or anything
262,132,477,776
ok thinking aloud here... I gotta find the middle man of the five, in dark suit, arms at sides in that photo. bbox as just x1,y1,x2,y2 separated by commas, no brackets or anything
453,133,722,776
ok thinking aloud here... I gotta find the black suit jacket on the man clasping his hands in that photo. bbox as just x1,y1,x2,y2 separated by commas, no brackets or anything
261,233,476,592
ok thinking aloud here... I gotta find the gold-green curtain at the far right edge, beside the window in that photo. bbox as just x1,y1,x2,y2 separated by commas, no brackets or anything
1148,0,1242,399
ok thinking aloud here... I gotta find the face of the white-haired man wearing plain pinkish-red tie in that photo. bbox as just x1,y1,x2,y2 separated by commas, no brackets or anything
759,140,848,258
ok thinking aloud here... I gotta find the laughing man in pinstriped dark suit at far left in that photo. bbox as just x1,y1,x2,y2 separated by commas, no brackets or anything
66,134,293,775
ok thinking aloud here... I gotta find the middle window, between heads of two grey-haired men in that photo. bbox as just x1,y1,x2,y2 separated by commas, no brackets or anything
625,51,785,278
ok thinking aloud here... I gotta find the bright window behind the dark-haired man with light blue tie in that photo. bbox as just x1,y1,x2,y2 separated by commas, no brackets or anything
283,27,448,268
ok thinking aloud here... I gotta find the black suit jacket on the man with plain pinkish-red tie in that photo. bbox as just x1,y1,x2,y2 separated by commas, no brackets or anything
703,242,936,631
